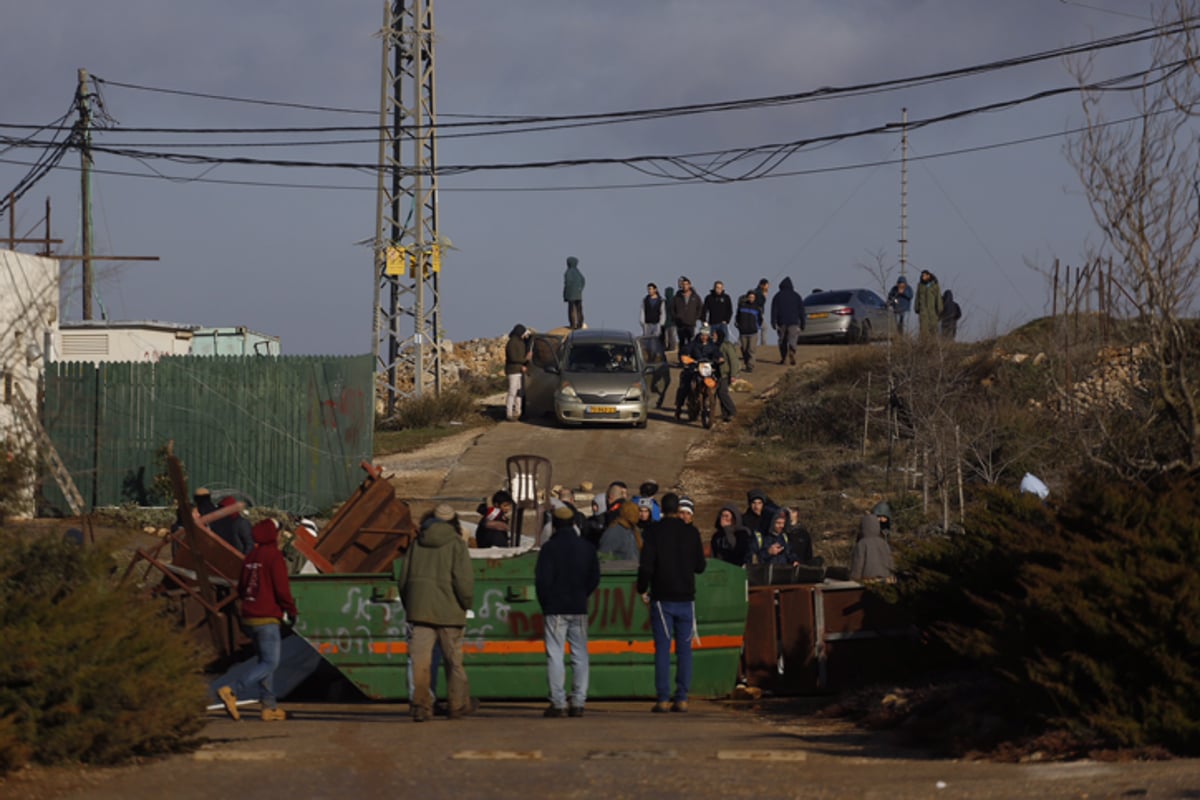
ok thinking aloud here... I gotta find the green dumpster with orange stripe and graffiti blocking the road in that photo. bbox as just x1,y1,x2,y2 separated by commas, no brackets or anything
292,552,746,700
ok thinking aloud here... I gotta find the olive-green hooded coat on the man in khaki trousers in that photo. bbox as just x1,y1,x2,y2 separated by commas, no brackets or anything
397,517,475,627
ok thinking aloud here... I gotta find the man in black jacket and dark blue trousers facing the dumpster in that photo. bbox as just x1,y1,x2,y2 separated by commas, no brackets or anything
637,492,708,714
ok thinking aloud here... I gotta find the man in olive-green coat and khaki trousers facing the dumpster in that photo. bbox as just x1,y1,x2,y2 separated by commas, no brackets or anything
398,504,475,722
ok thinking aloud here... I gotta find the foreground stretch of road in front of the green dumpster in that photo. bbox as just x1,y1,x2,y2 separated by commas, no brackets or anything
11,702,1200,800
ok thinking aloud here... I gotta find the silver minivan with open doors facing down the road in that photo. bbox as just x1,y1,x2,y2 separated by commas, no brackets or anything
526,330,654,427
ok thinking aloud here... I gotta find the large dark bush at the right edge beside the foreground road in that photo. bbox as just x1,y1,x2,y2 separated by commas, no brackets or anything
896,475,1200,754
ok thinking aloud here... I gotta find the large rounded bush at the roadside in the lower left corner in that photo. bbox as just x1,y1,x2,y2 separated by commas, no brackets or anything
0,530,206,774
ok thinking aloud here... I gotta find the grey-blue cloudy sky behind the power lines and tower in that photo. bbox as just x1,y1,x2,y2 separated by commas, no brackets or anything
0,0,1152,354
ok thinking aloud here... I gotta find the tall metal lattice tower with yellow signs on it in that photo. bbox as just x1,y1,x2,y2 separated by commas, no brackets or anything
372,0,442,415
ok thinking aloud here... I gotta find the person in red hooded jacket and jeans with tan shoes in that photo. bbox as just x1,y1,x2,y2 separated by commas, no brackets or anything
217,519,298,722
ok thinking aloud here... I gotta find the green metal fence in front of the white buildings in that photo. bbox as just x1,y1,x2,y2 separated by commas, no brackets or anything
42,355,374,513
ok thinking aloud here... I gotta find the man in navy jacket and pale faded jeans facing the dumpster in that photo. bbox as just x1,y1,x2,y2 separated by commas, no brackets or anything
534,503,600,717
